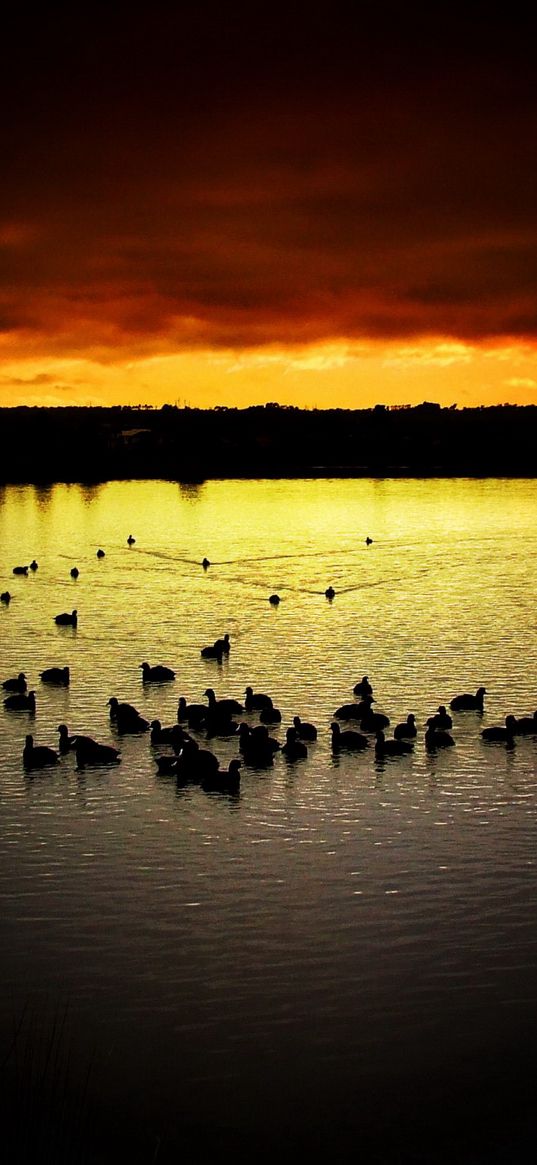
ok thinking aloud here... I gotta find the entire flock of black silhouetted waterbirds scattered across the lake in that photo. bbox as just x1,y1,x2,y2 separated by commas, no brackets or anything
0,535,537,792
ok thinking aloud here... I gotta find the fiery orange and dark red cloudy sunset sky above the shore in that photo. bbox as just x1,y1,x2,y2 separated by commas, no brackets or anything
0,2,537,408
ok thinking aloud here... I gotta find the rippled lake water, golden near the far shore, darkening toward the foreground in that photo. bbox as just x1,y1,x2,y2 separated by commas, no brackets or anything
0,479,537,1163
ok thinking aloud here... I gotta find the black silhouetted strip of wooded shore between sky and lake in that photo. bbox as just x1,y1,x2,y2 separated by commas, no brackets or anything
0,402,537,482
